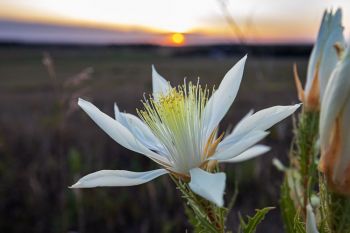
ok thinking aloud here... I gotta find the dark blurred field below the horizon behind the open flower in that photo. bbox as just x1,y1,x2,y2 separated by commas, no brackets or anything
0,47,307,233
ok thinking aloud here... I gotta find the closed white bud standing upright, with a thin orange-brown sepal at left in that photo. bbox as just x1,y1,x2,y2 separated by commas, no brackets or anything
294,9,345,110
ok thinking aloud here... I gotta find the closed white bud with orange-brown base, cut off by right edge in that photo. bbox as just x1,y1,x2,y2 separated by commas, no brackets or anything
320,47,350,195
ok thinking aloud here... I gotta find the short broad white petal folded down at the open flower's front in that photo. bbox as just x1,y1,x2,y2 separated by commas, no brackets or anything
189,168,226,207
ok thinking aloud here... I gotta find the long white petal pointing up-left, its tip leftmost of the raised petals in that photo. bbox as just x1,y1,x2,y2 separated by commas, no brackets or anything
78,99,168,163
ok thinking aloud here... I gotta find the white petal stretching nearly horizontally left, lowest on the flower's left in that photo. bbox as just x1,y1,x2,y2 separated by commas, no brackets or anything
71,169,169,188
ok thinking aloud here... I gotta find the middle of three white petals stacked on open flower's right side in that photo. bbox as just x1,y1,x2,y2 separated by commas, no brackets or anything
209,131,268,161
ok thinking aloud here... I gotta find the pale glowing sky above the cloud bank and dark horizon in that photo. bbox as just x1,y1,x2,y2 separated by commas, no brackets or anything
0,0,350,43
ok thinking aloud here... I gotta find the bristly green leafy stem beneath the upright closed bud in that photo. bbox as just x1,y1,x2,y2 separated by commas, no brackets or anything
280,111,319,233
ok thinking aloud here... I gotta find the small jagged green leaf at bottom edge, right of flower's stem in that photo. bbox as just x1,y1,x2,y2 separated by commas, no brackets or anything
239,207,274,233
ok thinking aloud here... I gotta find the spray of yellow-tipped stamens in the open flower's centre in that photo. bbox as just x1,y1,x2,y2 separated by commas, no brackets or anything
137,82,209,174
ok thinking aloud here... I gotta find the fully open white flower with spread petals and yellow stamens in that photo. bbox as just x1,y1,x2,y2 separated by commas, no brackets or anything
72,56,299,206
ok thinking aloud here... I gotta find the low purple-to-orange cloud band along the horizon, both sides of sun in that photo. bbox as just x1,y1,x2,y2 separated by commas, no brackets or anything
0,20,249,45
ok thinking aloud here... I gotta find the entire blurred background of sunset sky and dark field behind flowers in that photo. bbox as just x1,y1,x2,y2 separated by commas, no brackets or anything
0,0,350,232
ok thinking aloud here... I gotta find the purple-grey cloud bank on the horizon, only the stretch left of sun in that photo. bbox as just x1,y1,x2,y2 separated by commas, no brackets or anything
0,20,162,45
